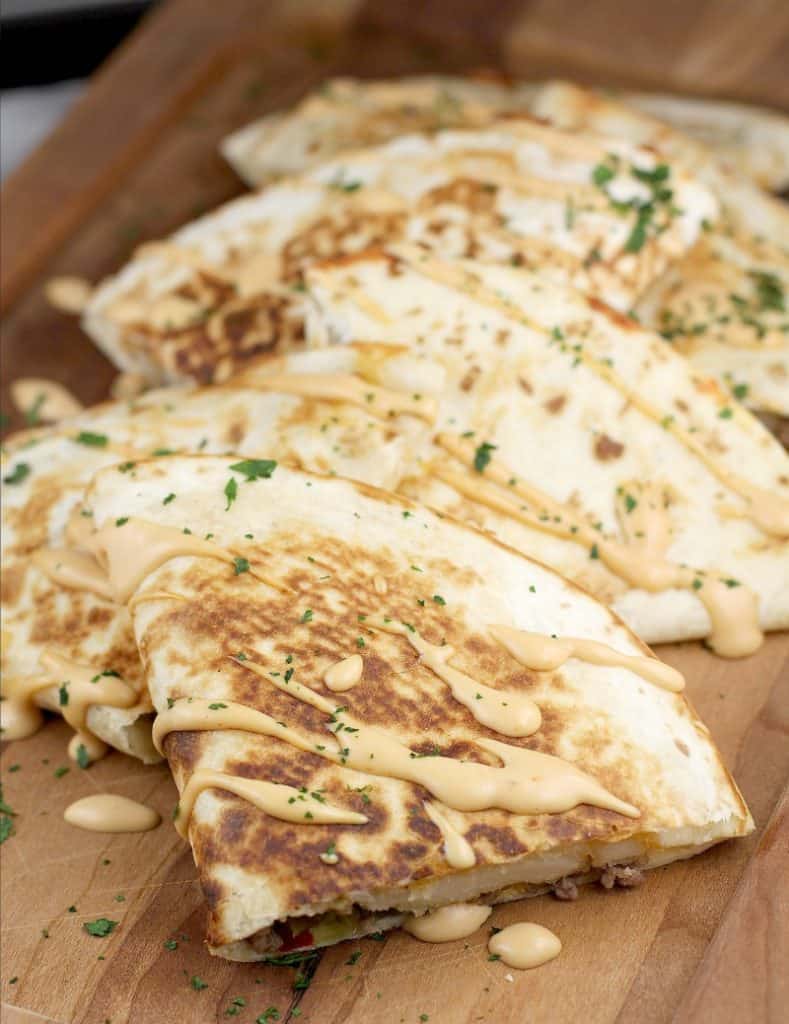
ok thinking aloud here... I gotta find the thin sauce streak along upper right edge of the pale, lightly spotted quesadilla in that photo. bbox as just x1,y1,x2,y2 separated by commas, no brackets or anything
407,256,789,537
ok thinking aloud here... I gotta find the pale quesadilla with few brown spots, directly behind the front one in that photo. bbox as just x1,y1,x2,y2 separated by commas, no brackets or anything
307,249,789,656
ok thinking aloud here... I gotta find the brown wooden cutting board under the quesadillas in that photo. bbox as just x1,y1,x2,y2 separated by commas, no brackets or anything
0,0,789,1024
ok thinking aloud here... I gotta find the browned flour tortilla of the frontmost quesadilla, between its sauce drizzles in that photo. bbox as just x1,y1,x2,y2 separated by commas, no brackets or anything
88,457,752,961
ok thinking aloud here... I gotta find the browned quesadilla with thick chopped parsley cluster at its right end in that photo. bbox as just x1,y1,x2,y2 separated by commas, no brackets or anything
84,121,717,381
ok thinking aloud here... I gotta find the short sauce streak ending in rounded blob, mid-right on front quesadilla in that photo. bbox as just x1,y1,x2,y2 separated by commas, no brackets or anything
364,615,542,736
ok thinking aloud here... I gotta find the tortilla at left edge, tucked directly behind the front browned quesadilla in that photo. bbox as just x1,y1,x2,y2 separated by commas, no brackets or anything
2,352,427,762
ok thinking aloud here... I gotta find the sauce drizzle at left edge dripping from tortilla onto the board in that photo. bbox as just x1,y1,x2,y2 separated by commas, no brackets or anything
0,648,137,760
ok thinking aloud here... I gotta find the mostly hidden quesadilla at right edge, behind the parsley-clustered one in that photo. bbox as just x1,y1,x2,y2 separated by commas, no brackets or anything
534,82,789,416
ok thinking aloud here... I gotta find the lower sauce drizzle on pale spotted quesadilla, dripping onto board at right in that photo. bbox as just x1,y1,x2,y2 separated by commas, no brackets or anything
434,434,764,657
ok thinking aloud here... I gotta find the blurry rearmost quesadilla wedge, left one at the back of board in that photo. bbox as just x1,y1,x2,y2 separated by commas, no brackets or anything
220,75,534,188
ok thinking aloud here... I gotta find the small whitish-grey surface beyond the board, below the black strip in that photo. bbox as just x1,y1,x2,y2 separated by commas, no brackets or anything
0,80,85,178
